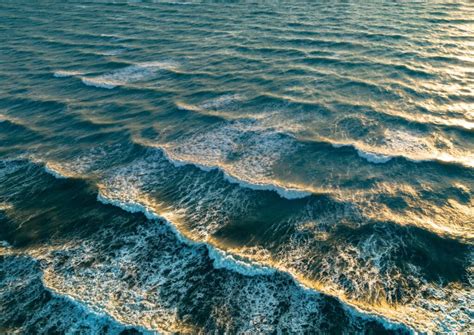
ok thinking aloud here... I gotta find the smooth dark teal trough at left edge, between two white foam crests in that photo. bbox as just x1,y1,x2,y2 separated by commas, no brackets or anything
0,162,120,247
